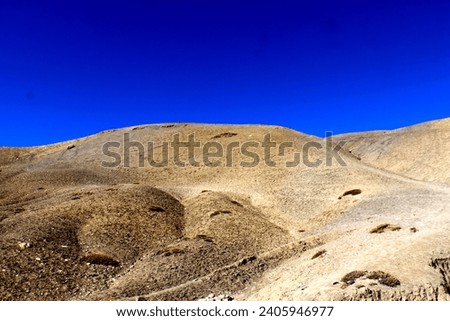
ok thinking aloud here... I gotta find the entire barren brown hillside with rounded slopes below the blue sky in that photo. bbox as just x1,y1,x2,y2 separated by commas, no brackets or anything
0,120,450,300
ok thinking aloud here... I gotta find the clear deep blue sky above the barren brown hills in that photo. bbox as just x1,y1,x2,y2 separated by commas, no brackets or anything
0,0,450,146
